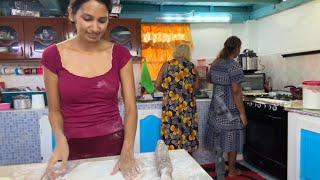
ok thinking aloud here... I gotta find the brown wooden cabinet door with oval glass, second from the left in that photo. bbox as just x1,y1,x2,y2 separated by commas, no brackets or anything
24,18,64,59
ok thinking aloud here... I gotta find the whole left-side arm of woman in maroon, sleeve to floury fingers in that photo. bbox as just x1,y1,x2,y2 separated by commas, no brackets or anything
44,68,69,173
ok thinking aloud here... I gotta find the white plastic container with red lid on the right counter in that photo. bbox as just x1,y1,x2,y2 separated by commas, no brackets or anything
302,81,320,109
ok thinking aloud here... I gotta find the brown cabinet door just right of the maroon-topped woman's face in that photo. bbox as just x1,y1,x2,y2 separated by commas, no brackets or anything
105,19,141,57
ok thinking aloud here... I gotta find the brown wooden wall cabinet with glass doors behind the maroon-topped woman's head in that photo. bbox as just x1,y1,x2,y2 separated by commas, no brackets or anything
0,17,141,60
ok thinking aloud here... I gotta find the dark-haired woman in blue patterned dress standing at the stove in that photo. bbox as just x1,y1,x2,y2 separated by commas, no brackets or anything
205,36,247,176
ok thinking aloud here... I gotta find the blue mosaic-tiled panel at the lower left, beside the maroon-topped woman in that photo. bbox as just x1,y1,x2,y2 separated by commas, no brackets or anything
0,111,41,165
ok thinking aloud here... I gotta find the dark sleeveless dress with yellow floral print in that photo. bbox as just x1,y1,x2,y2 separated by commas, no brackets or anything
161,59,199,152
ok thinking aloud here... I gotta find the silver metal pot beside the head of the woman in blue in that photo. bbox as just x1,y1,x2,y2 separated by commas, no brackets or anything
238,49,258,72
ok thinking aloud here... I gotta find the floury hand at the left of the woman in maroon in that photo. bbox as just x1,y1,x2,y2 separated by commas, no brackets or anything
46,135,69,179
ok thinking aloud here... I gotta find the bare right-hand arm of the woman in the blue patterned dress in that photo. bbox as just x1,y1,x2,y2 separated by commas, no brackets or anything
232,83,248,126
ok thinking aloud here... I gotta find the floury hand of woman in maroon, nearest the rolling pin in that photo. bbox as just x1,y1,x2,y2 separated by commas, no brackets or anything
111,152,140,180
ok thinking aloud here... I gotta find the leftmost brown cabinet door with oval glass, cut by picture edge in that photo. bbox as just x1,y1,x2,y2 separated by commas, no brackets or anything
0,18,25,60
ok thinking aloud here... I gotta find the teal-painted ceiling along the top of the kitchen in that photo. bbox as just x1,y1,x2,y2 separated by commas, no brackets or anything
43,0,312,23
